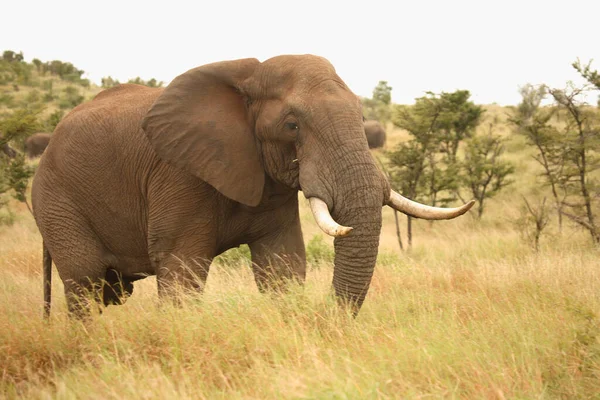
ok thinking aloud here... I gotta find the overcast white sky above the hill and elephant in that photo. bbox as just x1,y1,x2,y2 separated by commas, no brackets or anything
0,0,600,105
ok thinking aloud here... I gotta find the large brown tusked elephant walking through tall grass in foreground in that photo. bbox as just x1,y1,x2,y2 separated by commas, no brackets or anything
32,54,473,318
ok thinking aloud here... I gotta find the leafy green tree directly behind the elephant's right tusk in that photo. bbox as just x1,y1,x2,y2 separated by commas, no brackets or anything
387,91,483,247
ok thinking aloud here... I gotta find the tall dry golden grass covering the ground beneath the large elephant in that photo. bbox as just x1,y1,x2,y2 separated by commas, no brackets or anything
0,106,600,399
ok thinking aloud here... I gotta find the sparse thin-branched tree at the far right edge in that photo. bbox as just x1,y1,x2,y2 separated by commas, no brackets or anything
511,60,600,244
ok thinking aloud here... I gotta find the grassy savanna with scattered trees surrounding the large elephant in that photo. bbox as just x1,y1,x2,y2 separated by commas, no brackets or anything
0,52,600,399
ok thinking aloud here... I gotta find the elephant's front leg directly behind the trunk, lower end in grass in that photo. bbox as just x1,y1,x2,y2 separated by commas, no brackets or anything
249,215,306,292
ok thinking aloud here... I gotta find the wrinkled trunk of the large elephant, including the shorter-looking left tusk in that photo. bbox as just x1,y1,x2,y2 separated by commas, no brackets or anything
297,103,390,315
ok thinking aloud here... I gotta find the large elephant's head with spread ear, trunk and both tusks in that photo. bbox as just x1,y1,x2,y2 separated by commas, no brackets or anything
142,55,472,311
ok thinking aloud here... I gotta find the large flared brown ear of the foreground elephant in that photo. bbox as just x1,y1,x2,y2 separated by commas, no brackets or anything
142,58,265,206
